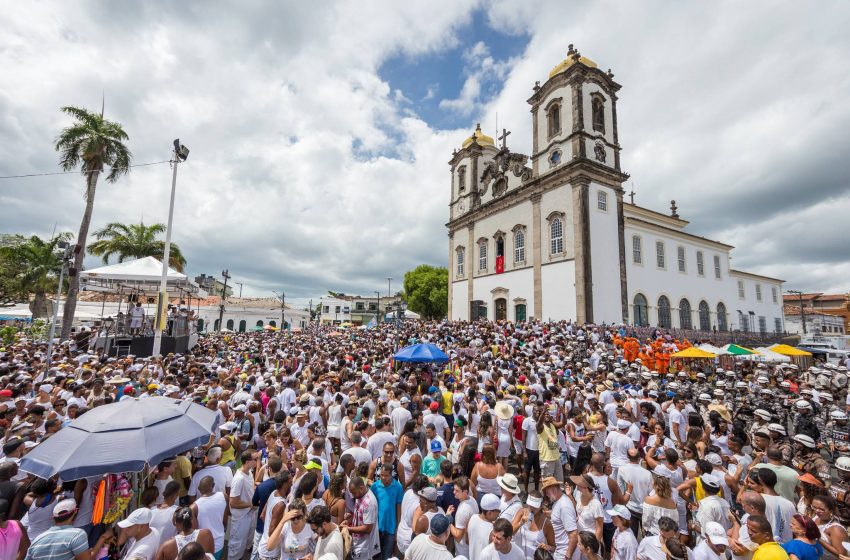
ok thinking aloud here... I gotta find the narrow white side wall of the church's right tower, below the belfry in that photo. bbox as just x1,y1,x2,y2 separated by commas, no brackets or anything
588,183,623,323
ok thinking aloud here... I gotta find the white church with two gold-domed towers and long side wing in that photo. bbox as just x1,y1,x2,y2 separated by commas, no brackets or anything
447,45,784,333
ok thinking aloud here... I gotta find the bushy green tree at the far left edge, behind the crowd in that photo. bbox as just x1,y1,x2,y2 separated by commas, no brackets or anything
0,233,71,318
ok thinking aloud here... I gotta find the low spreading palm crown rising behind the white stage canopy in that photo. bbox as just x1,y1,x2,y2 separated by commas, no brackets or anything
89,222,186,272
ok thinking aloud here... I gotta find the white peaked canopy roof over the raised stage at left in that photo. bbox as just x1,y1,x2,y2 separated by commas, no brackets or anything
80,257,207,297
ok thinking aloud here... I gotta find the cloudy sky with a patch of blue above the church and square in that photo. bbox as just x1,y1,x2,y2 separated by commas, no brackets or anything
0,0,850,301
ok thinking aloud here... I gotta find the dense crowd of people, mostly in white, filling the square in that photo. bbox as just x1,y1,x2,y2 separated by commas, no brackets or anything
0,322,850,560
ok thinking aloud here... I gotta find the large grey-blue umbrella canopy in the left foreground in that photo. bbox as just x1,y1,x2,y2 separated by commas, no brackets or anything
20,397,218,480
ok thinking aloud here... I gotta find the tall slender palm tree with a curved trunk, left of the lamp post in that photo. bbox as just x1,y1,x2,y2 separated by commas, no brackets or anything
56,107,133,340
